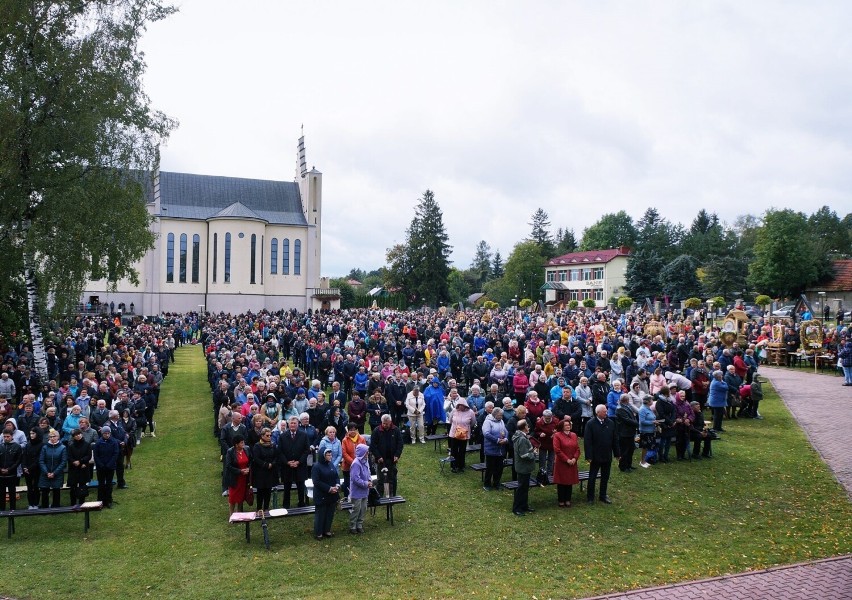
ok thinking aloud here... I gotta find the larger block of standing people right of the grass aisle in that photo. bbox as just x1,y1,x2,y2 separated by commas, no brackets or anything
200,300,848,537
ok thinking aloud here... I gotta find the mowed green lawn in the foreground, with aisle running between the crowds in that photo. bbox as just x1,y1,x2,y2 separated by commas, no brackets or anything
0,347,852,599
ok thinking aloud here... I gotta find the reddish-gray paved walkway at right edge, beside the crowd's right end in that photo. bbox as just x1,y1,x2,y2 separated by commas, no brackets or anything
760,367,852,500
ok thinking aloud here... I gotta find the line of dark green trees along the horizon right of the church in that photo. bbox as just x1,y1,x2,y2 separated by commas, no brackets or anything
337,195,852,306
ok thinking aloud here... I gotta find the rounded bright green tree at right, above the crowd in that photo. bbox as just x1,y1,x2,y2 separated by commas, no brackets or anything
748,209,824,297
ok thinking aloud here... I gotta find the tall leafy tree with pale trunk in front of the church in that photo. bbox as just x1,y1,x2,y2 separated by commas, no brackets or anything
0,0,174,377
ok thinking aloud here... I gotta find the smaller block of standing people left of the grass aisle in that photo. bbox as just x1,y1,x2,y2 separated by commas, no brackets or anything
0,315,191,510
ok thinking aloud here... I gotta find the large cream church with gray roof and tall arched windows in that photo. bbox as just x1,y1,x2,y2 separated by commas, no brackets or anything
82,137,340,315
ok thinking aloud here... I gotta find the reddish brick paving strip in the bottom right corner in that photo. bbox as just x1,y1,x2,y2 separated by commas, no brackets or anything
588,555,852,600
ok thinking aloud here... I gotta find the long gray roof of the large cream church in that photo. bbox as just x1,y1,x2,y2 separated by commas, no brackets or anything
160,171,307,225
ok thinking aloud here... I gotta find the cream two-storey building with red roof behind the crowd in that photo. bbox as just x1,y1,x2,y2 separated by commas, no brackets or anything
541,246,630,307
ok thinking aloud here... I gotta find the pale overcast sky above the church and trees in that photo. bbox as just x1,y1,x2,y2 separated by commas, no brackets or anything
143,0,852,276
